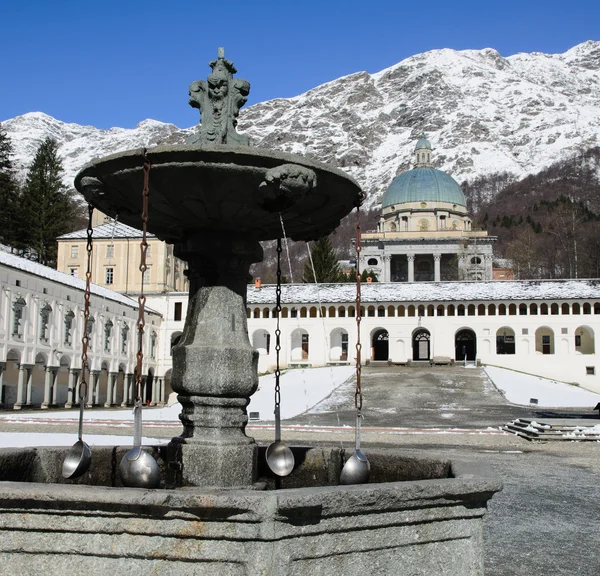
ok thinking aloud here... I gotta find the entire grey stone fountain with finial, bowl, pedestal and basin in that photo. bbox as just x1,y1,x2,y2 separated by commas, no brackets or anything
0,49,501,576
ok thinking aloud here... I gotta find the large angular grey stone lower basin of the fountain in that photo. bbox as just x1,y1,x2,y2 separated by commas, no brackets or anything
0,447,501,576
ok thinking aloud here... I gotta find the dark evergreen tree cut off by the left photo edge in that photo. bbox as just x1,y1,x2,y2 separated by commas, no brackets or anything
0,124,19,247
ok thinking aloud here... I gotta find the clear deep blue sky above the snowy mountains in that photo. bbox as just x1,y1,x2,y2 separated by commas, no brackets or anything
0,0,600,128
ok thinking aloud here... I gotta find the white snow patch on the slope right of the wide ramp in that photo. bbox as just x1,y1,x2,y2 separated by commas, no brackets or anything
485,366,600,408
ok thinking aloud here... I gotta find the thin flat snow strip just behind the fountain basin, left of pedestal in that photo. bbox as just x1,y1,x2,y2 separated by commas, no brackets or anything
0,432,165,448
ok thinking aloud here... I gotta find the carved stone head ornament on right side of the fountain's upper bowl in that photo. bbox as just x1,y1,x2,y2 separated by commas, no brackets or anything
258,164,317,212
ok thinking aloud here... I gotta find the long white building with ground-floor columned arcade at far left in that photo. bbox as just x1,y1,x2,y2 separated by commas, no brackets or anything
0,251,165,409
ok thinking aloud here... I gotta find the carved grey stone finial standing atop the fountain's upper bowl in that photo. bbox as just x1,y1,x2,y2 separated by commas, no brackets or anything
188,48,250,146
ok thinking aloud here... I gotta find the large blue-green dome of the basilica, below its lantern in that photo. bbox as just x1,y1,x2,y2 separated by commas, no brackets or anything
381,168,467,208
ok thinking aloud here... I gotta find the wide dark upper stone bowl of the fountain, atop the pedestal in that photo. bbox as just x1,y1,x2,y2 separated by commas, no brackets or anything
75,143,362,243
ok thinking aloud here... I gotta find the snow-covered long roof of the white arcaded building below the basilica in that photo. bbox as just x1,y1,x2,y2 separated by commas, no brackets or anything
248,280,600,305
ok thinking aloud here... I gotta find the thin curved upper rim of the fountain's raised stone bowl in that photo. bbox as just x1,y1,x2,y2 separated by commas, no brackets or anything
74,143,360,190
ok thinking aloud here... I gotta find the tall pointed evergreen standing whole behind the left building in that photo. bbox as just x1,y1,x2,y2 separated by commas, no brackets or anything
19,138,77,266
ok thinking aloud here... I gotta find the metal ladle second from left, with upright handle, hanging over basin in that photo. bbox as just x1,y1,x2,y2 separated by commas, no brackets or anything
119,398,160,488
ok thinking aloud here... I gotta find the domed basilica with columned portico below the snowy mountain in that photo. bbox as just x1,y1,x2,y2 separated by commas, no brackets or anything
361,135,496,282
